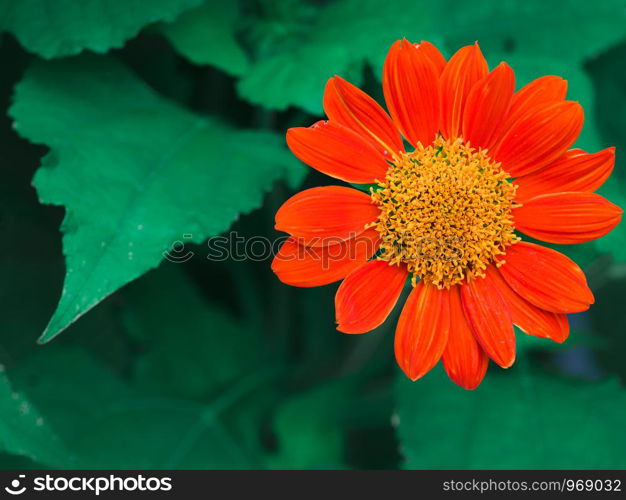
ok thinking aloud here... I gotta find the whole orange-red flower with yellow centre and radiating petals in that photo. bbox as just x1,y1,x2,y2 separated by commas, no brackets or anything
272,40,622,389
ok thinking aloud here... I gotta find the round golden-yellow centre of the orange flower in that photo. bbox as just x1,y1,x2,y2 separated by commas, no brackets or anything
371,137,519,288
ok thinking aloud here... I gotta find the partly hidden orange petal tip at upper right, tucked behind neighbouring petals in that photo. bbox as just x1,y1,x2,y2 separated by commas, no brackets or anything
504,75,567,134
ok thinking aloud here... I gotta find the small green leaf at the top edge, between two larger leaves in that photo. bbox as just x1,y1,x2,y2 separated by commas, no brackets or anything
159,1,248,76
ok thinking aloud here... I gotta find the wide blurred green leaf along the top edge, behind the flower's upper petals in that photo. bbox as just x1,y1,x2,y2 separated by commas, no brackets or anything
239,0,626,113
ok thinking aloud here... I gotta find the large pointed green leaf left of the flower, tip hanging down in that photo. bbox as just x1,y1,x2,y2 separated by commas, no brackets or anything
10,57,302,341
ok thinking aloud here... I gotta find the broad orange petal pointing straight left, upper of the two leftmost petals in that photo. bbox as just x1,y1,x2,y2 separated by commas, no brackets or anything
275,186,380,246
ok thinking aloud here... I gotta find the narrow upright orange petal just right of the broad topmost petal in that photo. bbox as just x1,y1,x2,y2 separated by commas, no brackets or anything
440,43,489,139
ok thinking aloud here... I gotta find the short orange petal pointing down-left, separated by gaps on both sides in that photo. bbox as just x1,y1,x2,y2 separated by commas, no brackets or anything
335,260,409,333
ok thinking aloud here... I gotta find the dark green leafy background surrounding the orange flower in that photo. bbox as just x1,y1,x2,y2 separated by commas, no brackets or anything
0,0,626,469
